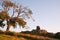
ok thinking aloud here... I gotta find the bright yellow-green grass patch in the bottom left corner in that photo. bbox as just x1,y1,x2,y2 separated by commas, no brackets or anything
0,34,25,40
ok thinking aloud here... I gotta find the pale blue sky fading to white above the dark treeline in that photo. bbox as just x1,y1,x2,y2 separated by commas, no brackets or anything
0,0,60,33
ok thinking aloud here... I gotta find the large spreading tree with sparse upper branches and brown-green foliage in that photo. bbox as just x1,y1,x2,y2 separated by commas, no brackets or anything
0,0,32,31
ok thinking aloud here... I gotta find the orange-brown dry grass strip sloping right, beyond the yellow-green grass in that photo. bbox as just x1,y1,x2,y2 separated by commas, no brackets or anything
19,33,51,40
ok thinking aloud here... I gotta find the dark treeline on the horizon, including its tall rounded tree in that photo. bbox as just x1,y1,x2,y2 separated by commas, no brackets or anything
21,26,60,39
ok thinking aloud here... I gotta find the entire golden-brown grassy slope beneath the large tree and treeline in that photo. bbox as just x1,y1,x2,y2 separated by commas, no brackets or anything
0,32,59,40
